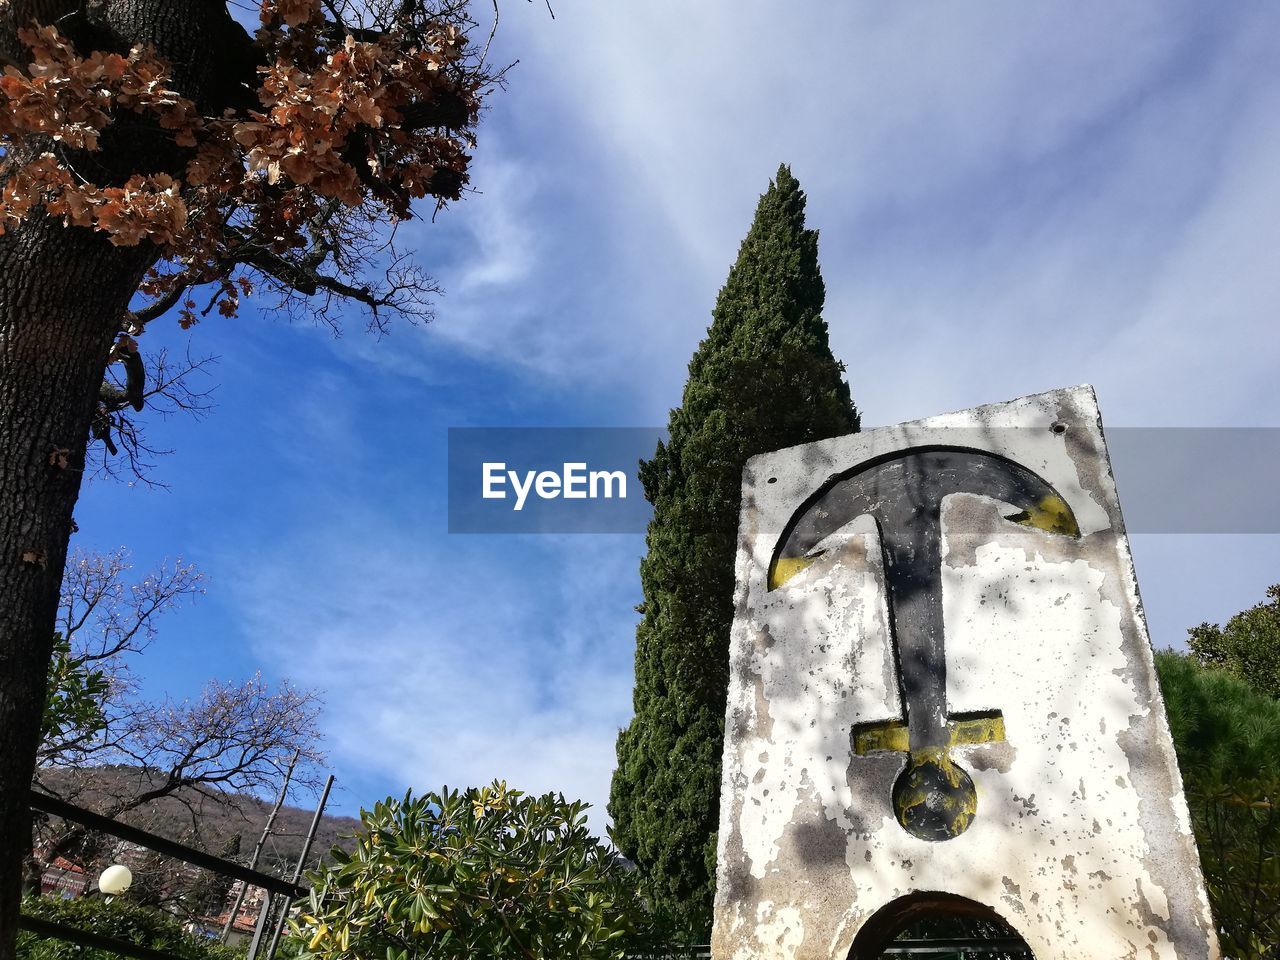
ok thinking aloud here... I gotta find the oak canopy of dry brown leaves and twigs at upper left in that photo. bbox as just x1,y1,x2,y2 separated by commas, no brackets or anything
0,0,492,330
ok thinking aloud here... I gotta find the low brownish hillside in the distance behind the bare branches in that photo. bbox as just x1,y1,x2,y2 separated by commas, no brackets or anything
38,767,360,874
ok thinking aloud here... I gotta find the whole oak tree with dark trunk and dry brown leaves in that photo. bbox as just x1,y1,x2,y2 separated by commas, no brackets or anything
0,0,500,960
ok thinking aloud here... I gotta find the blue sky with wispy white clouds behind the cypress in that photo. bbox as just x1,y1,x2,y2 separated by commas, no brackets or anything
74,0,1280,827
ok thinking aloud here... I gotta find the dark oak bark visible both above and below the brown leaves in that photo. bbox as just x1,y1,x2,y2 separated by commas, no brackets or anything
0,0,253,960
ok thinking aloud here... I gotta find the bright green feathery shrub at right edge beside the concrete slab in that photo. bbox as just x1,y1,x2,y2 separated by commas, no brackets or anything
1156,652,1280,960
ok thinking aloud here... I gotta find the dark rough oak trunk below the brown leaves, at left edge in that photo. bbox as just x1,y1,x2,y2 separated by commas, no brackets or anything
0,213,155,960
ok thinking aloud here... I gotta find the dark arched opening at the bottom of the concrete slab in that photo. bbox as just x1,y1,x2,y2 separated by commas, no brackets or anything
849,891,1034,960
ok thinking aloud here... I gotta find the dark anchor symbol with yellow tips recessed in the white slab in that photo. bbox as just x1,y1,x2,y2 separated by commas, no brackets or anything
769,447,1080,840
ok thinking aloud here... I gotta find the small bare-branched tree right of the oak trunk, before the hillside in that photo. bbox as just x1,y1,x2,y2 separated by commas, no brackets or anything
27,549,324,914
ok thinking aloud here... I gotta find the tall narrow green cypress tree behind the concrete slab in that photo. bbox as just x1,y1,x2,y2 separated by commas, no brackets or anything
609,165,859,942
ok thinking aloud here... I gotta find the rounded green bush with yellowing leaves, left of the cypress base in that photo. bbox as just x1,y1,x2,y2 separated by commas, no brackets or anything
289,782,662,960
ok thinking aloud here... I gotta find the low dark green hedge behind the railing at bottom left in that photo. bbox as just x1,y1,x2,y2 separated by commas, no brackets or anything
17,896,242,960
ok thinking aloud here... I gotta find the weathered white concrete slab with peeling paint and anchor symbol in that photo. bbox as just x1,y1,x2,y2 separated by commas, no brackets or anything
713,387,1219,960
